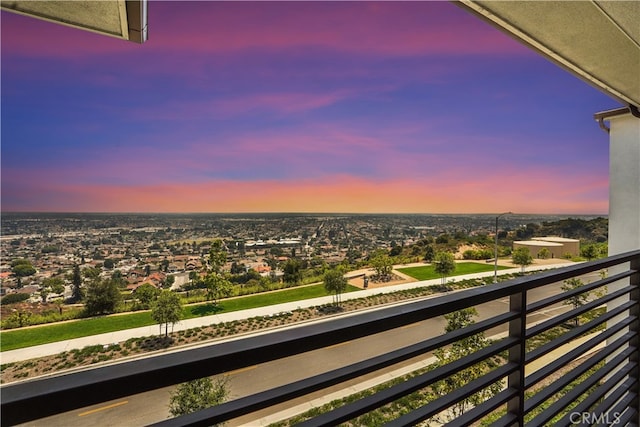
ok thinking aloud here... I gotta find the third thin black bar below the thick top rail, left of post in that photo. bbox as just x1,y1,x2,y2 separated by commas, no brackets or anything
386,364,519,427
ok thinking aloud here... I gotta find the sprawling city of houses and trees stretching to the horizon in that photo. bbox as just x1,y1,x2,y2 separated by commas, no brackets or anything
0,213,606,301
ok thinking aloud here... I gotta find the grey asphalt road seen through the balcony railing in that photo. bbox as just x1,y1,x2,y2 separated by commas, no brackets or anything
25,275,598,427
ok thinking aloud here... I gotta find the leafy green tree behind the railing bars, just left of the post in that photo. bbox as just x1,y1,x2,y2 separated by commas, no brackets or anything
431,308,502,423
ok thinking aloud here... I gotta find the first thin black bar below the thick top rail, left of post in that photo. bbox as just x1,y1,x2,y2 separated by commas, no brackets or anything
154,313,517,427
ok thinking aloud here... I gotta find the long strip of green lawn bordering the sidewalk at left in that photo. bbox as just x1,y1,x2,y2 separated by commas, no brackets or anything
0,285,359,351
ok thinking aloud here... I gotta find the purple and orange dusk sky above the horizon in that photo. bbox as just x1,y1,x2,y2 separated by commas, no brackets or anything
1,1,619,214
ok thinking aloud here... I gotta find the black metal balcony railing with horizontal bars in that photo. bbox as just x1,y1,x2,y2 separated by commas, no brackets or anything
1,250,640,426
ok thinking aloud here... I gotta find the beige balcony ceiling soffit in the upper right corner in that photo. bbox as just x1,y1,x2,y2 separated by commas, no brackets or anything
460,0,640,106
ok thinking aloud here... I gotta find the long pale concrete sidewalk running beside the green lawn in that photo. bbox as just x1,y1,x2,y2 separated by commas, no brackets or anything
0,263,575,364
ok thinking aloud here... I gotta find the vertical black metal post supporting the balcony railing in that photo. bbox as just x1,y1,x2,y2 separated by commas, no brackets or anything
507,289,527,427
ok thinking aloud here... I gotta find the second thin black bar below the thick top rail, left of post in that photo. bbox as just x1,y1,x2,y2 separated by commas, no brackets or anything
299,338,518,427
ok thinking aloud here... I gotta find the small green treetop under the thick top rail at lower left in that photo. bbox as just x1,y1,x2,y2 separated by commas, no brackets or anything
169,377,229,417
